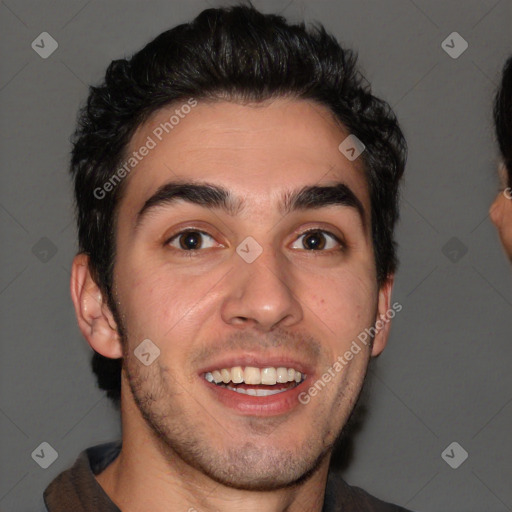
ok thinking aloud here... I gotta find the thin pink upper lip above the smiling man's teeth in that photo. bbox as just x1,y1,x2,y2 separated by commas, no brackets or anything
198,352,313,375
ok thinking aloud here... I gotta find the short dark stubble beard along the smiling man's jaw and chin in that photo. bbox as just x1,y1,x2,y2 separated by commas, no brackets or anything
114,296,368,492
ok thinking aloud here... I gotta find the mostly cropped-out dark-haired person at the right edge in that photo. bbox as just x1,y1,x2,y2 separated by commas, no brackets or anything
489,57,512,259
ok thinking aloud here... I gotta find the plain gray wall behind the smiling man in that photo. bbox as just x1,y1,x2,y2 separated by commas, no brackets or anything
0,0,512,512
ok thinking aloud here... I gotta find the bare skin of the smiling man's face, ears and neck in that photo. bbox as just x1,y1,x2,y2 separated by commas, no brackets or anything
71,98,392,512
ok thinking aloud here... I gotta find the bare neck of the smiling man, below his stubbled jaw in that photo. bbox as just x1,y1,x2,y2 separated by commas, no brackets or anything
96,424,330,512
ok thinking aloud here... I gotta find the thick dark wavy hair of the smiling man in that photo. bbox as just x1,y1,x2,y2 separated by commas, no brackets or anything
71,0,407,408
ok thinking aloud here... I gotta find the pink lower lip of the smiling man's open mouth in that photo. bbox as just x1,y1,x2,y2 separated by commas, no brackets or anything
200,377,309,416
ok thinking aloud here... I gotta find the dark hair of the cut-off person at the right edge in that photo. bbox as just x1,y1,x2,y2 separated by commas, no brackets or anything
494,57,512,187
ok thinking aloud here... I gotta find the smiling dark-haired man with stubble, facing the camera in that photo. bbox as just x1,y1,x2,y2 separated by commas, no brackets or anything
44,6,406,512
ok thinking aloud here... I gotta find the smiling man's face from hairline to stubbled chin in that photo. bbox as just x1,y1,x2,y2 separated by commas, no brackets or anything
114,99,388,489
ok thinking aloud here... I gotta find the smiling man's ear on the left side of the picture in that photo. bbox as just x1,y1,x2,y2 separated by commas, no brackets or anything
70,254,123,359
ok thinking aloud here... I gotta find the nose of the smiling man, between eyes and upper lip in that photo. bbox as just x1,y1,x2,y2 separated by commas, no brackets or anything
221,244,304,332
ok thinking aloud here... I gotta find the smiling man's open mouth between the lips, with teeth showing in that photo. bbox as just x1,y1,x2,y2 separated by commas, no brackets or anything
203,366,306,397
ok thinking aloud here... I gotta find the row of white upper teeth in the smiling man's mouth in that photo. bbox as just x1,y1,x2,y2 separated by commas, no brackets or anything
204,366,302,386
